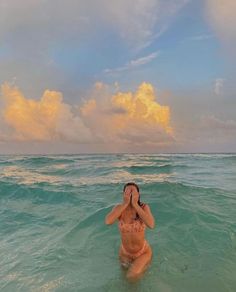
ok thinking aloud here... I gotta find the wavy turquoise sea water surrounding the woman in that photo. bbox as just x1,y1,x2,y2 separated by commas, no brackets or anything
0,154,236,292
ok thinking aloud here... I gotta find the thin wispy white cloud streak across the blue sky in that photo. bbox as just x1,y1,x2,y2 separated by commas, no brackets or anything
104,51,160,74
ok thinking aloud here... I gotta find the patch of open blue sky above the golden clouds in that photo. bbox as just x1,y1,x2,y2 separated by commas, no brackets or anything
50,1,225,89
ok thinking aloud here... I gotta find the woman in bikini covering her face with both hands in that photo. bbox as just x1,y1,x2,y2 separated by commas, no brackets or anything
105,182,155,279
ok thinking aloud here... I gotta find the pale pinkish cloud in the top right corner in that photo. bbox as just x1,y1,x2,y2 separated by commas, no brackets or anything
206,0,236,45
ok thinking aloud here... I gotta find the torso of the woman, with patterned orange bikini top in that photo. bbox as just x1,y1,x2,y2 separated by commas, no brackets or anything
118,204,146,253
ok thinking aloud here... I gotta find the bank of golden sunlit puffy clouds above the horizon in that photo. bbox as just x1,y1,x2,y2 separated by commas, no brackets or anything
0,82,174,147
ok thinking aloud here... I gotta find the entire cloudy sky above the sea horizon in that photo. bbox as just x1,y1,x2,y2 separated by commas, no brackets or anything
0,0,236,154
